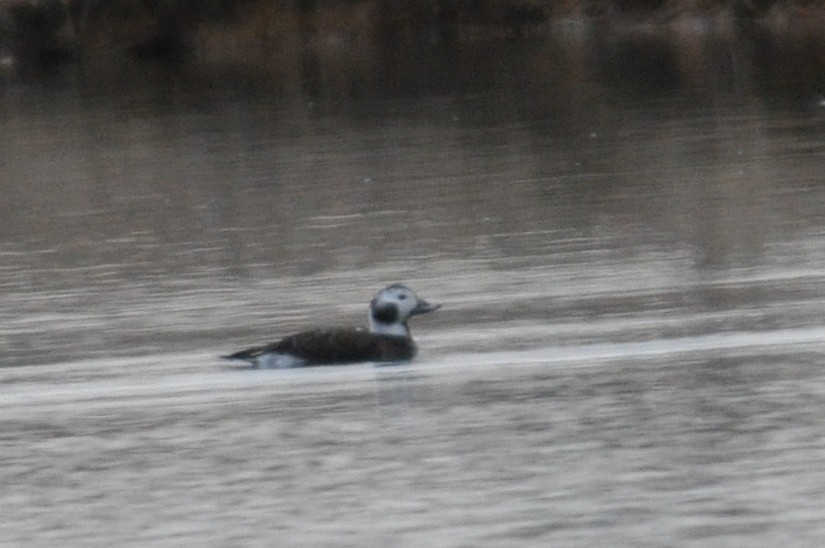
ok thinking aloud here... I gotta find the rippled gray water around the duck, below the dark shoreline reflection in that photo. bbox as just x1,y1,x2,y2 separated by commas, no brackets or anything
0,35,825,546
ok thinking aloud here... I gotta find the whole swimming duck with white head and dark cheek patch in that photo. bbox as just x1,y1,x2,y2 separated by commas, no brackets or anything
221,284,441,369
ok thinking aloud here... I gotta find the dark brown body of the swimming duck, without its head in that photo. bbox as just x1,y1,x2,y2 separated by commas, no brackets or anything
225,328,417,366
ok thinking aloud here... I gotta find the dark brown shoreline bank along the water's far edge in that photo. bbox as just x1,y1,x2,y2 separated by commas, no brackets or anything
0,0,825,66
